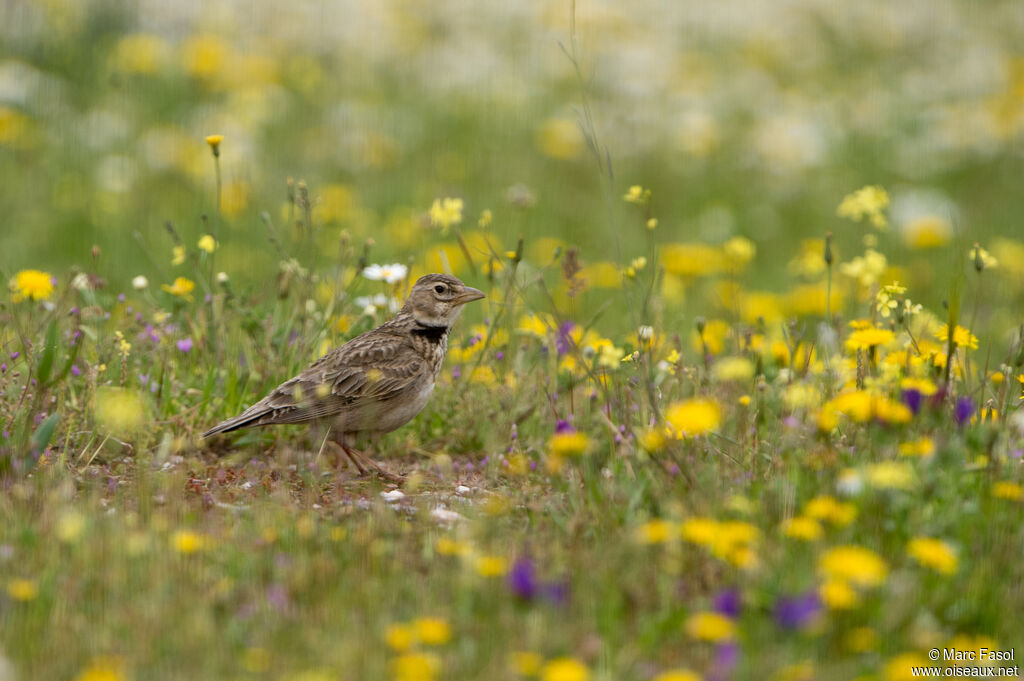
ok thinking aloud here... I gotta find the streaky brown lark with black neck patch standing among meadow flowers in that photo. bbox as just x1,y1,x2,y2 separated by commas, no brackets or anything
203,274,484,482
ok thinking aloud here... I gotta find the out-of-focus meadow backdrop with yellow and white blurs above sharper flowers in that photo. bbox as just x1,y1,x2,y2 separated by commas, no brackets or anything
0,0,1024,287
